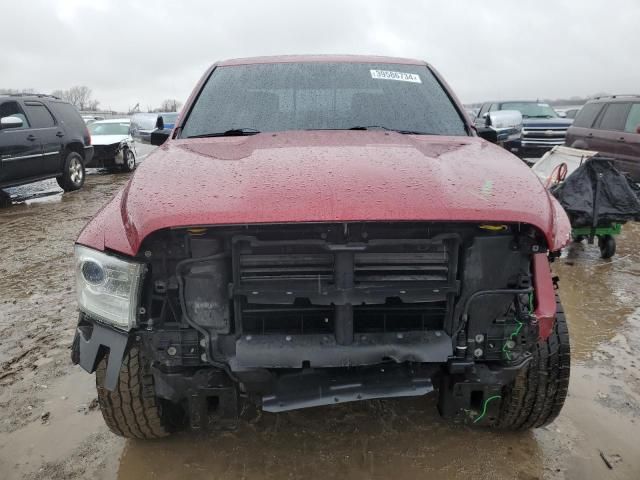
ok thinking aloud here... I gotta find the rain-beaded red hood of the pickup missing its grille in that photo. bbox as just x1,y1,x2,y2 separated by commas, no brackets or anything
78,131,570,255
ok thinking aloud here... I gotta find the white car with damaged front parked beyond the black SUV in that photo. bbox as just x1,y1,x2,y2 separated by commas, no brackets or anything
85,118,137,172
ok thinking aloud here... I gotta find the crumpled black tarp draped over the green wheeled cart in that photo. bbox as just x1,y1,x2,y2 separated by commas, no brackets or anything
551,156,640,228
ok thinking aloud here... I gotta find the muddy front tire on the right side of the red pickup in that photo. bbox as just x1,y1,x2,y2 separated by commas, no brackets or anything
495,296,571,430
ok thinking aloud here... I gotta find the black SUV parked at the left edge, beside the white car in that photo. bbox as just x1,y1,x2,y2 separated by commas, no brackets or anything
0,95,93,192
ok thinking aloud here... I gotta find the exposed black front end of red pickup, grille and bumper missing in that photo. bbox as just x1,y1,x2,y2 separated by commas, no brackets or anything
74,222,555,428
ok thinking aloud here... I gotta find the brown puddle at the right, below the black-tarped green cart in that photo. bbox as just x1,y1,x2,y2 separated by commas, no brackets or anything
553,223,640,359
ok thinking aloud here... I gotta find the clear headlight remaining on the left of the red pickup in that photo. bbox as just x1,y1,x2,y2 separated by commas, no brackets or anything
75,245,145,330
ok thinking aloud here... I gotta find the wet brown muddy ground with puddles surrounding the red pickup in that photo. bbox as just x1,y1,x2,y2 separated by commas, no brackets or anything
0,148,640,480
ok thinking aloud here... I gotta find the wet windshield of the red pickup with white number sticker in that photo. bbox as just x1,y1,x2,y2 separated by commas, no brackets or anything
181,63,467,137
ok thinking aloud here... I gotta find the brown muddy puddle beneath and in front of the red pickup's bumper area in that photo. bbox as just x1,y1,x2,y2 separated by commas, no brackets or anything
118,396,543,480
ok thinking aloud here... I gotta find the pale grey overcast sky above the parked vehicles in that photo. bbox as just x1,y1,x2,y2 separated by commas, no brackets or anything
0,0,640,110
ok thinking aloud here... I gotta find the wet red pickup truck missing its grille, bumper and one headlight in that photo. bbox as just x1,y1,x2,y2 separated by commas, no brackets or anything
72,56,570,438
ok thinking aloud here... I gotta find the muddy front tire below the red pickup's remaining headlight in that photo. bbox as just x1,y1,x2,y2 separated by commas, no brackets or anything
96,345,172,439
